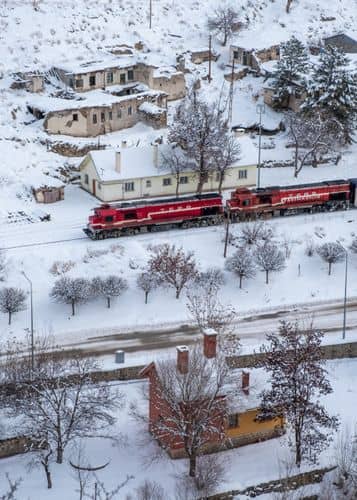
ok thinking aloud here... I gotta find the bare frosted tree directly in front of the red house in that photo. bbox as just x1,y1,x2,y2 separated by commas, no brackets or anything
147,345,229,477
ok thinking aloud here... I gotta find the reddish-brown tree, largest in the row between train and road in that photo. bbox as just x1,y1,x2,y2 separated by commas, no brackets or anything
148,243,197,299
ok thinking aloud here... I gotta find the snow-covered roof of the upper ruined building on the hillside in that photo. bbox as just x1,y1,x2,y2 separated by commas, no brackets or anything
56,55,136,75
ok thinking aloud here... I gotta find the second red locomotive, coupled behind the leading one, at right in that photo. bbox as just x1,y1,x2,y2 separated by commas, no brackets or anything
226,180,350,221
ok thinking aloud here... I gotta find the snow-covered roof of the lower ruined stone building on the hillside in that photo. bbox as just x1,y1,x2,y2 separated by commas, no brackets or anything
27,89,166,113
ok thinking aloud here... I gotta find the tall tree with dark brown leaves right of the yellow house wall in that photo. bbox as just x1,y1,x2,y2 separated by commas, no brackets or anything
259,321,338,466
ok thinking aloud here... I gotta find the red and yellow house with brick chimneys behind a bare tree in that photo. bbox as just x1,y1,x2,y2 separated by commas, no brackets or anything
141,330,285,458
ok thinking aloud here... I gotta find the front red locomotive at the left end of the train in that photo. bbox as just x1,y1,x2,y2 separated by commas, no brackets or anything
84,193,223,240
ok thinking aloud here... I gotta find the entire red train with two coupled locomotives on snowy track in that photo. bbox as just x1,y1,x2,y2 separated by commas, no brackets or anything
84,179,357,240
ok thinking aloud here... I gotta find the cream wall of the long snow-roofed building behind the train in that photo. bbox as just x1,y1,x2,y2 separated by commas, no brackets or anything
80,160,256,202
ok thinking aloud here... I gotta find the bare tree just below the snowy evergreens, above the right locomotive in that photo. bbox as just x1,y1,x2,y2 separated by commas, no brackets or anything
288,113,342,177
